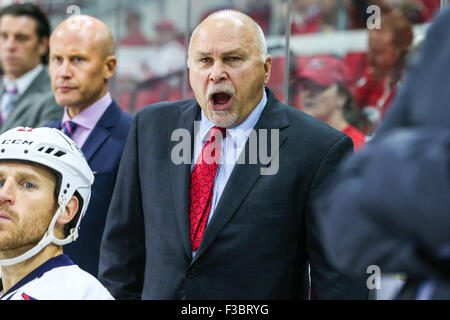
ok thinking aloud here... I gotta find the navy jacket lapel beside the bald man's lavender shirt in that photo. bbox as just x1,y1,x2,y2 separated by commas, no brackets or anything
81,101,120,162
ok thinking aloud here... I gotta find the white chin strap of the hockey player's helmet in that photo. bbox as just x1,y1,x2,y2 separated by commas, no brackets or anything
0,197,78,266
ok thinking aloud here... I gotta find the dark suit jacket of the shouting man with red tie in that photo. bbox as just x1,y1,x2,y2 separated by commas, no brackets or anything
99,90,365,299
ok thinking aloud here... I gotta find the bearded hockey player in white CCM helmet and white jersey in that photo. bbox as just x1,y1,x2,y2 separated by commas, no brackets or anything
0,127,113,300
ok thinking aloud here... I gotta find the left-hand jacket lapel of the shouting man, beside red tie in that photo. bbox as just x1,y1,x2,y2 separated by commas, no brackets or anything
167,99,201,260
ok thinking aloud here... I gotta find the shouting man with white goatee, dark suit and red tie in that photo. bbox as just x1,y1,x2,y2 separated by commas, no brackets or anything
99,10,367,299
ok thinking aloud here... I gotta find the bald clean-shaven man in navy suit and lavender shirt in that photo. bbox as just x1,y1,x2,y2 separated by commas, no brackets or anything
48,15,132,276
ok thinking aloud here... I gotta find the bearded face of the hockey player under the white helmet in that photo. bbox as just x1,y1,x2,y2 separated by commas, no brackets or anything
0,161,56,259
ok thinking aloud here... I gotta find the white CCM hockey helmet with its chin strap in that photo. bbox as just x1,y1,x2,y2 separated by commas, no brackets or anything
0,127,94,265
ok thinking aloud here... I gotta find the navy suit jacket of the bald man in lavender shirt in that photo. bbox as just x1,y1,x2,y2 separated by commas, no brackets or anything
47,101,132,276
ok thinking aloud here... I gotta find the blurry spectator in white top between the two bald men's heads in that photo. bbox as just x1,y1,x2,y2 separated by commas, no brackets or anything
147,19,186,78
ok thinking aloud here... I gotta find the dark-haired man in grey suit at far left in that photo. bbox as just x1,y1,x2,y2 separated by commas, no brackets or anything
0,3,63,133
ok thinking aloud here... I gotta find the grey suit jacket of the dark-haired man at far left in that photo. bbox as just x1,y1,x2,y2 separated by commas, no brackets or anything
0,67,64,133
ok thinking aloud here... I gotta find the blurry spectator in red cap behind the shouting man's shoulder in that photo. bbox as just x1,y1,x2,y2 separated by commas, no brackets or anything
299,56,365,150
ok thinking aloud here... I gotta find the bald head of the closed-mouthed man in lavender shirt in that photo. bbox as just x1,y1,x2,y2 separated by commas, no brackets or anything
49,15,117,118
